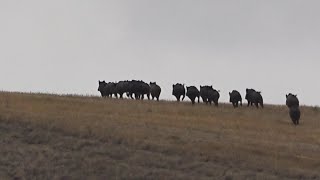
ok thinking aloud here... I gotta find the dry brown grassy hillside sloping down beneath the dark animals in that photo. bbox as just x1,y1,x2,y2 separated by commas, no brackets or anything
0,92,320,179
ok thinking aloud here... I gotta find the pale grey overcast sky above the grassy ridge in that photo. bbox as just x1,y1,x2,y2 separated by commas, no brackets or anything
0,0,320,105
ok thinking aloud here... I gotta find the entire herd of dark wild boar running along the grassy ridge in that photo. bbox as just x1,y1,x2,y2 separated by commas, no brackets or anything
98,80,301,125
